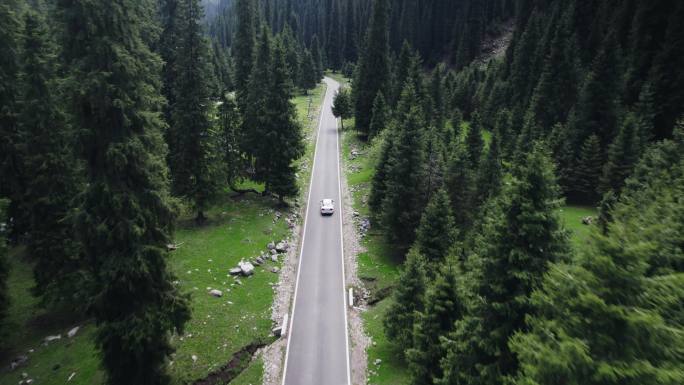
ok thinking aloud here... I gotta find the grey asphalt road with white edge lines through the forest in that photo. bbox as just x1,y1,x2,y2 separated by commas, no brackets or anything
283,78,350,385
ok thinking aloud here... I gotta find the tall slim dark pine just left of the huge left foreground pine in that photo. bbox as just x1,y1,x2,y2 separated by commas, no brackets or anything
19,11,85,306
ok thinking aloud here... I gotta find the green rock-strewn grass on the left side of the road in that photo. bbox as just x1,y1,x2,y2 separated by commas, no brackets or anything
0,84,325,385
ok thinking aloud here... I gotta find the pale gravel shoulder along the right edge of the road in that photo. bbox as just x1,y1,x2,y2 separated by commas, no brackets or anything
340,138,370,385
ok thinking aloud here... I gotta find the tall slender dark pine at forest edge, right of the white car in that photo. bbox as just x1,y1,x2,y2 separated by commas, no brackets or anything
382,83,427,248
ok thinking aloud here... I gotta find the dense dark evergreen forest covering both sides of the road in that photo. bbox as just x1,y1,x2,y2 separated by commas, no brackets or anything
0,0,684,385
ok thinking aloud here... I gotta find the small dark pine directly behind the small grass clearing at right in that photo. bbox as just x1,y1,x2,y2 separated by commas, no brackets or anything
574,135,602,203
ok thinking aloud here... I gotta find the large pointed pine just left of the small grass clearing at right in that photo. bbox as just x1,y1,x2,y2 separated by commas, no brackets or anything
442,145,568,384
